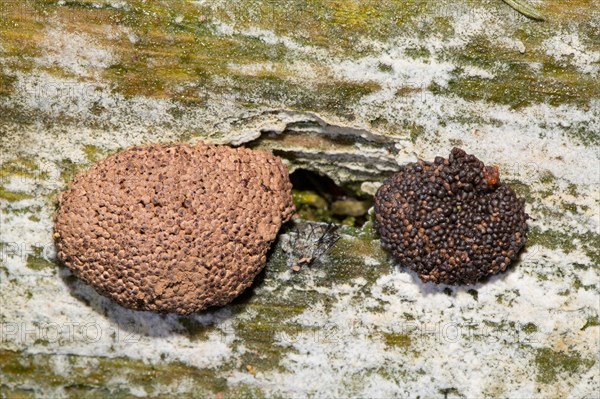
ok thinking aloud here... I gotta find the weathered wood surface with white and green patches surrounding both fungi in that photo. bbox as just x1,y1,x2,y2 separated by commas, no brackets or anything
0,0,600,398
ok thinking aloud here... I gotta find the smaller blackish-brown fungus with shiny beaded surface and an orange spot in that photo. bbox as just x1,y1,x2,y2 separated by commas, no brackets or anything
375,148,528,284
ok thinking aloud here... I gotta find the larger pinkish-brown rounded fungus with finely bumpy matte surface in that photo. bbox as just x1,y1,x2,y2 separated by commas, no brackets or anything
54,144,294,314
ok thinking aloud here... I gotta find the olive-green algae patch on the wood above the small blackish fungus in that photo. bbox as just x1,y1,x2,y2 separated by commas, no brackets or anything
432,28,598,112
